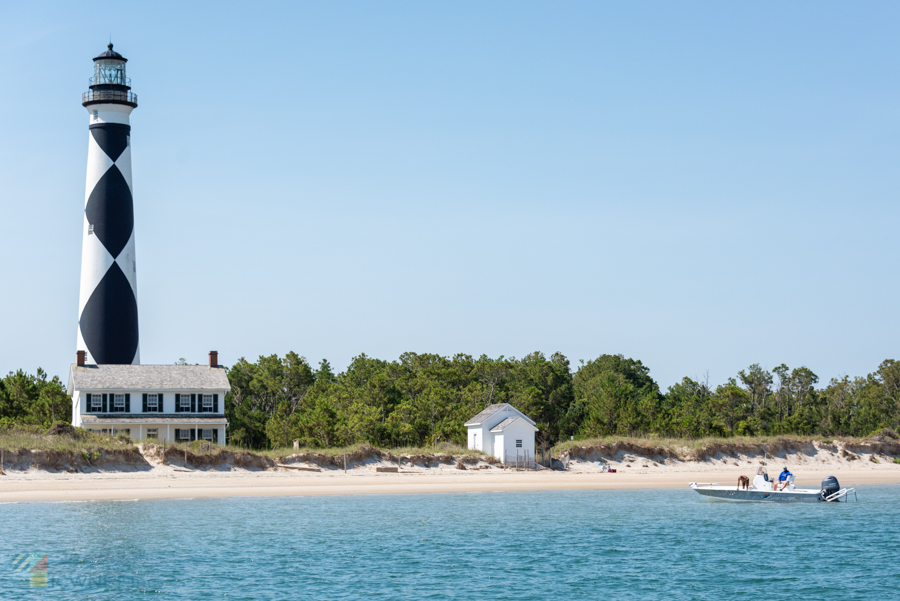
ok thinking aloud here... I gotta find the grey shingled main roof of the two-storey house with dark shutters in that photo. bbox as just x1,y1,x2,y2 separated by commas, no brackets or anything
68,365,231,394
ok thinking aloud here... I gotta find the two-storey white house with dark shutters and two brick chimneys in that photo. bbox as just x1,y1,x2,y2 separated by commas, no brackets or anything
68,351,231,444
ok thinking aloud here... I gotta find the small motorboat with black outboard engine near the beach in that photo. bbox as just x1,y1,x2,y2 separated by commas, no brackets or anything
690,467,856,503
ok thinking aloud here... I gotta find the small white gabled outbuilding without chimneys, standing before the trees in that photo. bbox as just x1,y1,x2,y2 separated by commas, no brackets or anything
465,403,538,463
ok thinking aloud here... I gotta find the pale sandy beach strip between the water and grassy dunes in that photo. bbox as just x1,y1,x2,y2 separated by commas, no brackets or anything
0,462,900,503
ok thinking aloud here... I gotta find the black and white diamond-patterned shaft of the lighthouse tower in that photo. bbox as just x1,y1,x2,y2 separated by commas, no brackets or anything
78,123,140,364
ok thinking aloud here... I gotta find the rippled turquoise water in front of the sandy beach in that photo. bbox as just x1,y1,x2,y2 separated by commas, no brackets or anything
0,486,900,601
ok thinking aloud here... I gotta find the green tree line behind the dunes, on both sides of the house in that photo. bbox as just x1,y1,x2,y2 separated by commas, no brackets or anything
0,352,900,448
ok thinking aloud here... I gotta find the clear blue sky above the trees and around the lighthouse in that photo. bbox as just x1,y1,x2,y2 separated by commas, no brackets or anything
0,1,900,387
